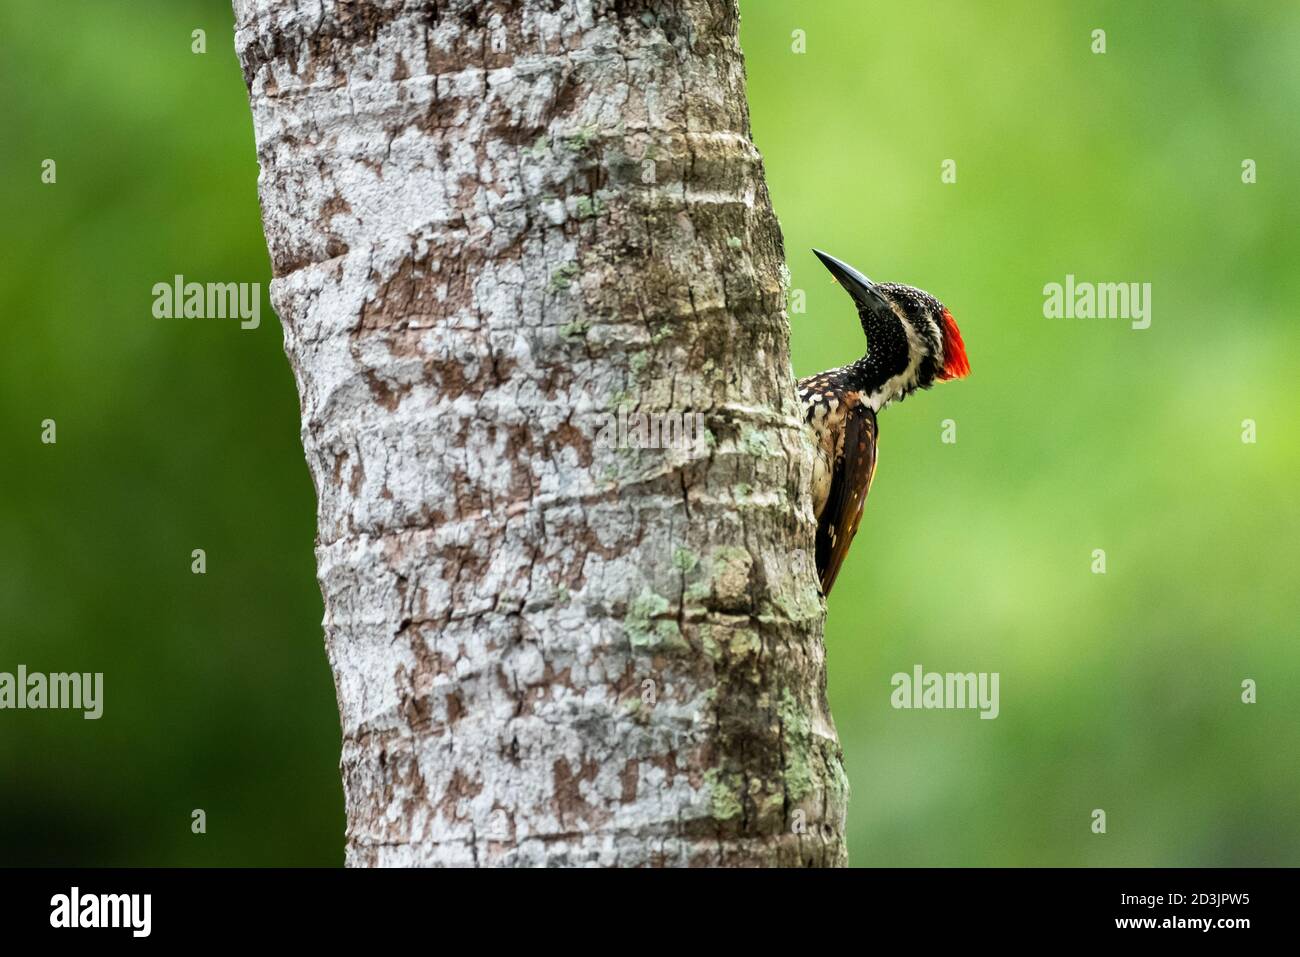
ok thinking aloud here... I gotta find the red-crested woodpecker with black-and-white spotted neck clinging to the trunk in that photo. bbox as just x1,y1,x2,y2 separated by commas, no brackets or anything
798,250,971,594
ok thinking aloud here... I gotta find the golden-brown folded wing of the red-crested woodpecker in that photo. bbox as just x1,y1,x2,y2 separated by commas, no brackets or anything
816,393,876,596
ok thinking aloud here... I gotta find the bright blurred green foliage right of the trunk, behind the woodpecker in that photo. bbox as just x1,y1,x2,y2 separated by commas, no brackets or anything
741,0,1300,866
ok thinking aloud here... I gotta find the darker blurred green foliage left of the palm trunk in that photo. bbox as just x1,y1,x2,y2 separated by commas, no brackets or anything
0,0,343,866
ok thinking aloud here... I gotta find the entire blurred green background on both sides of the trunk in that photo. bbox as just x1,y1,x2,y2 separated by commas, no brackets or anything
0,0,1300,866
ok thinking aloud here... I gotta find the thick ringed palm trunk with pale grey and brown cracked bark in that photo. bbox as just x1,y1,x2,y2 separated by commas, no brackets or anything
234,0,846,866
